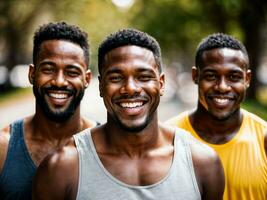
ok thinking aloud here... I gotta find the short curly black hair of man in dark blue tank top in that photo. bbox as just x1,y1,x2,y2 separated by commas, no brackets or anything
33,22,90,67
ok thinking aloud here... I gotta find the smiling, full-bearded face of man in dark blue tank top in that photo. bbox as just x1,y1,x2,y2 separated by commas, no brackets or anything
29,40,91,122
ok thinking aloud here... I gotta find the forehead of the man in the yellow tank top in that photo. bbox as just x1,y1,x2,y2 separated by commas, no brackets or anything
200,48,248,70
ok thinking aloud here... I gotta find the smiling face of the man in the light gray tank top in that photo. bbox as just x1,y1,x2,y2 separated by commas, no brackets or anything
99,45,164,132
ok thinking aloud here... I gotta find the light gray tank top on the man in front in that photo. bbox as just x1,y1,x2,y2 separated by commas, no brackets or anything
74,129,201,200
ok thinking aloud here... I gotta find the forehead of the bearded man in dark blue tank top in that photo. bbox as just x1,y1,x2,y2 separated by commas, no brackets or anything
37,40,85,61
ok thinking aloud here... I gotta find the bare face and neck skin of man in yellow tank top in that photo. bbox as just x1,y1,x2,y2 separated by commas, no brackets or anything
190,48,251,144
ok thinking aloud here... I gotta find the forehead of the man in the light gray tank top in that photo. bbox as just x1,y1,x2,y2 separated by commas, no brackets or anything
101,45,157,72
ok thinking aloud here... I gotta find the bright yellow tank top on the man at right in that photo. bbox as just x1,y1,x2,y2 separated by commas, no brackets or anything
167,109,267,200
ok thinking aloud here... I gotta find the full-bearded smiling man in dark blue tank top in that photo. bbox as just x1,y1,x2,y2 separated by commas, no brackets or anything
0,22,96,200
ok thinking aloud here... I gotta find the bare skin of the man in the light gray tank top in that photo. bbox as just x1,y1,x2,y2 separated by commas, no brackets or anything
33,45,224,200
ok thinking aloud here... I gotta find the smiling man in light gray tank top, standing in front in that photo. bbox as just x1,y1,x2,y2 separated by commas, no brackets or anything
33,29,224,200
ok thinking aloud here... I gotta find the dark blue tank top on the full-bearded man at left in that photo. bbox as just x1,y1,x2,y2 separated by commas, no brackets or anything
0,120,37,200
